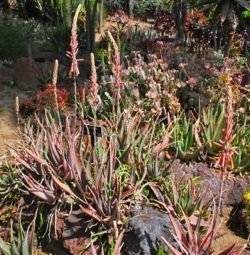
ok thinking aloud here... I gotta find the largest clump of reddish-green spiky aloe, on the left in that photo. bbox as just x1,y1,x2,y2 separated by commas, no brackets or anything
12,109,145,237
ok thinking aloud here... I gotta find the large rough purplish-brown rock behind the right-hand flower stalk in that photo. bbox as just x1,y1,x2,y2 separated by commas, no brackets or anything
170,160,250,206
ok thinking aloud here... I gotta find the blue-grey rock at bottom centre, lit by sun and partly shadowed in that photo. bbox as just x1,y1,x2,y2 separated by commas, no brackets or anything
123,206,177,255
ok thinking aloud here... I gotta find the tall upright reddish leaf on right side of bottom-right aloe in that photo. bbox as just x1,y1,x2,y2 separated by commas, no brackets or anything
199,202,217,253
